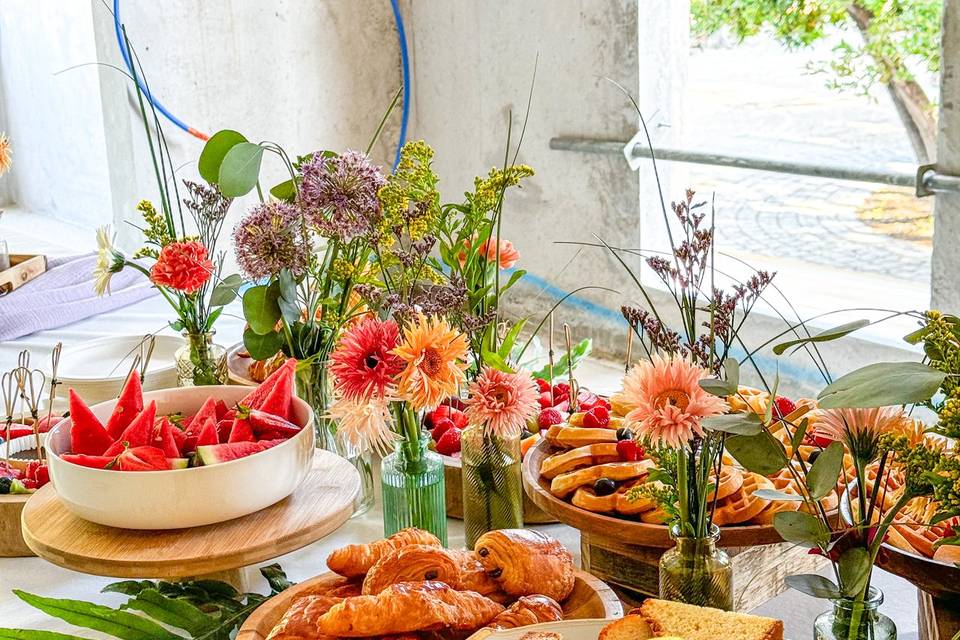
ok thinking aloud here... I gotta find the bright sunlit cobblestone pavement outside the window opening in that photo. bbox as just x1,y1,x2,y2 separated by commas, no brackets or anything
671,31,930,285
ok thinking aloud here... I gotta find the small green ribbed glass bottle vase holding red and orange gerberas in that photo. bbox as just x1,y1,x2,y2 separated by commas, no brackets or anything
380,435,447,546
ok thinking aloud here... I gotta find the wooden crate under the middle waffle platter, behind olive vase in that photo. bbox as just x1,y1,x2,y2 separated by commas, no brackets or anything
580,531,827,611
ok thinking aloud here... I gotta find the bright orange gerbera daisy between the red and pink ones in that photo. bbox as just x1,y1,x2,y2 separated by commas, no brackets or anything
393,315,467,411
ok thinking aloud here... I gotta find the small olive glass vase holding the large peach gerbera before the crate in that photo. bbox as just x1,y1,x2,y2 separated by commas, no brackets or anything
660,525,733,611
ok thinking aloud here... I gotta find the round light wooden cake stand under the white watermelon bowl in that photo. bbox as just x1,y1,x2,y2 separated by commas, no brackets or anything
21,450,360,591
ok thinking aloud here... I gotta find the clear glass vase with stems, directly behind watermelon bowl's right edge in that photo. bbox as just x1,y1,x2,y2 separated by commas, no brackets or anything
296,361,376,518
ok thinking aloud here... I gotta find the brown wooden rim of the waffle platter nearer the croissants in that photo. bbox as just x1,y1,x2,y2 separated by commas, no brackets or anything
523,440,783,549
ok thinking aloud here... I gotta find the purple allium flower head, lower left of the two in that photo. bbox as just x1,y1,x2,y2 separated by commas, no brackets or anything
233,202,310,280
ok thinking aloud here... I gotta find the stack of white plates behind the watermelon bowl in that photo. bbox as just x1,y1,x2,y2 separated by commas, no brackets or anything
58,336,183,405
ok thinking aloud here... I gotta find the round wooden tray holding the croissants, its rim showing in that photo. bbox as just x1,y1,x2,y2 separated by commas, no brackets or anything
236,571,623,640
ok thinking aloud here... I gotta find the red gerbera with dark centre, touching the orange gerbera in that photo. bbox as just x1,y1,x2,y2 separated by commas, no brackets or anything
330,318,404,401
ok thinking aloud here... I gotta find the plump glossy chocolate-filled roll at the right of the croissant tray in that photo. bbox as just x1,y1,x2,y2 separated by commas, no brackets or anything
475,529,574,602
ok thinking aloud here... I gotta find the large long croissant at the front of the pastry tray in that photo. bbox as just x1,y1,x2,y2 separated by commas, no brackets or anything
317,581,503,638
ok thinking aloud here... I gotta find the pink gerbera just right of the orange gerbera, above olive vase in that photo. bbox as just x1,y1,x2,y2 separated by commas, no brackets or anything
466,367,540,436
